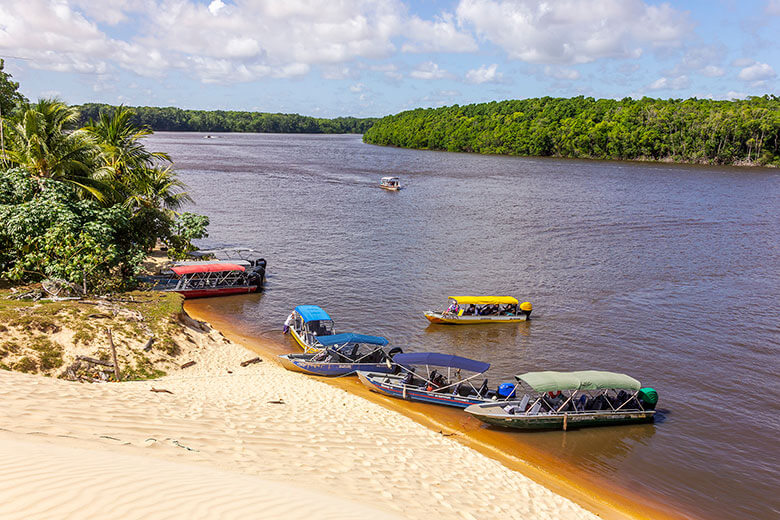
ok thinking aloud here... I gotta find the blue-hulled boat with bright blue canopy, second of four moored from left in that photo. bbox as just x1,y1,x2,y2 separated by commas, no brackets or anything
279,332,403,377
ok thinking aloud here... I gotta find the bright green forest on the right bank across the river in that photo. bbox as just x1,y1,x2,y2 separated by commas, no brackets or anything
363,95,780,166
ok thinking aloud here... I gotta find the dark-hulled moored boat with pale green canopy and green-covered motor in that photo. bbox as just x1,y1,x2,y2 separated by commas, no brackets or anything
466,370,658,430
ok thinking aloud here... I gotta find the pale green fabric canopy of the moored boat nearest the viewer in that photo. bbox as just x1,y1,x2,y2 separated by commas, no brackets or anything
515,370,642,392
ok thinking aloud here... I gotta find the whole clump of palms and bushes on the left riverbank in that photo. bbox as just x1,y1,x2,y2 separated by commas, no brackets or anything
0,61,208,291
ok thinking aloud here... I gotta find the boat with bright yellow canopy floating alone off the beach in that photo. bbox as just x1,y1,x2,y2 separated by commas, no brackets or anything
425,296,533,325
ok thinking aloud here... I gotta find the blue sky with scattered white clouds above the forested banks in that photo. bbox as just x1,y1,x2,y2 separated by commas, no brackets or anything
0,0,780,117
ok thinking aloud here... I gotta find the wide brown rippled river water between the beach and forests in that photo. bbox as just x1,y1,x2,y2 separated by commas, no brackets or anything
150,133,780,519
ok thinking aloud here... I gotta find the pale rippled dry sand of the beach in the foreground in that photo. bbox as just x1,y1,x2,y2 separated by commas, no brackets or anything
0,316,597,519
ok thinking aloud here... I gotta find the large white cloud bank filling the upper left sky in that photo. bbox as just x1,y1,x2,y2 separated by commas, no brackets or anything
0,0,477,83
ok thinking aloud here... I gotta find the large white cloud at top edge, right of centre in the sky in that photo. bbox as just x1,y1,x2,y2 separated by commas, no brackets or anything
456,0,690,63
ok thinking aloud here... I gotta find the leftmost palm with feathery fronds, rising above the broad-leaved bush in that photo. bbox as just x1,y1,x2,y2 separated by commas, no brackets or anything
5,99,107,200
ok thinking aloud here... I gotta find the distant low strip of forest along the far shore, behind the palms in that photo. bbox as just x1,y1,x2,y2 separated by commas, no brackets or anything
74,103,376,134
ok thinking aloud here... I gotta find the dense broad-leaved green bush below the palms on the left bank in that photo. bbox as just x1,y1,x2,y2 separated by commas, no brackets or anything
0,169,149,289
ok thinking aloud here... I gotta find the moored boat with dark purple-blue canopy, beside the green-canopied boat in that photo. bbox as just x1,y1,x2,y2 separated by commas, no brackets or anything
357,352,515,408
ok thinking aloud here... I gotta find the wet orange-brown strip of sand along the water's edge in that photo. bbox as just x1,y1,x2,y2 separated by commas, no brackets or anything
184,300,693,520
